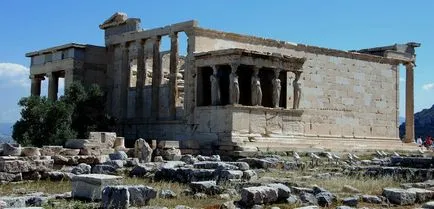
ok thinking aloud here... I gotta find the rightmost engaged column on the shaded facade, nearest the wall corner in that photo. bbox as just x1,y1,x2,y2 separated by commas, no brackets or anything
169,32,179,119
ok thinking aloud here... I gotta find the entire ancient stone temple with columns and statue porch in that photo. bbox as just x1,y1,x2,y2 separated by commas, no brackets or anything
26,13,420,154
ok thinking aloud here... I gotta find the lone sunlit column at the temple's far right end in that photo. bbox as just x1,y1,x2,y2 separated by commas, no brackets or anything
404,62,414,143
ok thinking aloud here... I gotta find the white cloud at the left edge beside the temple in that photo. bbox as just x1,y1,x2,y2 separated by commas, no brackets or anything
0,63,30,87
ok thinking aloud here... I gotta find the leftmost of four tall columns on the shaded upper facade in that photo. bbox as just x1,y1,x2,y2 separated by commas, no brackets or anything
119,43,130,119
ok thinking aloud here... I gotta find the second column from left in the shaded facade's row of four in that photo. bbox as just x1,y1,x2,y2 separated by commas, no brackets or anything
135,40,146,118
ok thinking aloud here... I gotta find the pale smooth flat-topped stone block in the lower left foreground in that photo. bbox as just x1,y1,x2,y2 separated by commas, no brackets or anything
71,174,122,201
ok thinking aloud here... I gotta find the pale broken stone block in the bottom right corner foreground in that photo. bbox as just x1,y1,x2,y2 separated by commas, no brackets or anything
383,188,416,205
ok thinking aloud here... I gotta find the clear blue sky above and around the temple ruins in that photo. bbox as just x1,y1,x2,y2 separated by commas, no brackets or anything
0,0,434,122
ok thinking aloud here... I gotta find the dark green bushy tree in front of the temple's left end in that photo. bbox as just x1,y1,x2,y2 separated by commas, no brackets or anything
12,82,114,147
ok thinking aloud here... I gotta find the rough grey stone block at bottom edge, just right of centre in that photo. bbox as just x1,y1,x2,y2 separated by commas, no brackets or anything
240,186,278,206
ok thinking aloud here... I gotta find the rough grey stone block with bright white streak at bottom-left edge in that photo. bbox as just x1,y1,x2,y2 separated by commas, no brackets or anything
102,185,157,209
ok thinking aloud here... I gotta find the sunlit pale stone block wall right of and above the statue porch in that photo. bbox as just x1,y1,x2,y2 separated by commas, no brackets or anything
195,35,399,139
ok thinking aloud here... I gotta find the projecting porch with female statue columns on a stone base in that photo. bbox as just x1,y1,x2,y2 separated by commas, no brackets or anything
194,49,305,143
